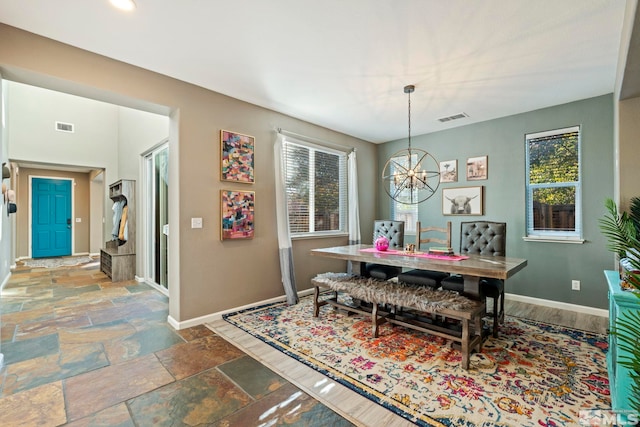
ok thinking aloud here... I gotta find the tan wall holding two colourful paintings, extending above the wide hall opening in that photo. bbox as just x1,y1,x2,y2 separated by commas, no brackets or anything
0,25,378,321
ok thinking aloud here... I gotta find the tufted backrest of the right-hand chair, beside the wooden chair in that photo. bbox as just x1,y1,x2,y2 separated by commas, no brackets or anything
460,221,507,256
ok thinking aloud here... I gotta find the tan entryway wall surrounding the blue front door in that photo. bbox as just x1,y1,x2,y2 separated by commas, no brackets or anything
16,168,91,258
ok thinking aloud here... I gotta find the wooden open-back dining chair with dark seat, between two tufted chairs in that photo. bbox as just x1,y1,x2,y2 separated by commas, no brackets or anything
398,221,451,289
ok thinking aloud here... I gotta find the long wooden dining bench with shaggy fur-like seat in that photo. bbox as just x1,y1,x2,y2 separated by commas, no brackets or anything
311,273,486,369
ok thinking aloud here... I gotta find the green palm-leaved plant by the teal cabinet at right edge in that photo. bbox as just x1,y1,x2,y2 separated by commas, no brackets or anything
600,197,640,412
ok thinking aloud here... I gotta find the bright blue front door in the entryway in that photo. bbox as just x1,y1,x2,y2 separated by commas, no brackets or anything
31,178,72,258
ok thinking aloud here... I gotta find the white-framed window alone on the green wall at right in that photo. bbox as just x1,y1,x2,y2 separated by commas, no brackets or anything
525,126,582,240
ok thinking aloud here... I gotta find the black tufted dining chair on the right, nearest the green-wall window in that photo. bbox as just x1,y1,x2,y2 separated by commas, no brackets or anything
442,221,507,338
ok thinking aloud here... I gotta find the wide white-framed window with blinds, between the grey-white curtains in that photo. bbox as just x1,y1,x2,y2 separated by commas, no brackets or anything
283,139,347,237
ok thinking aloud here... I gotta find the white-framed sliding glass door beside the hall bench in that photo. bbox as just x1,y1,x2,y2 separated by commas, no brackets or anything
143,141,169,295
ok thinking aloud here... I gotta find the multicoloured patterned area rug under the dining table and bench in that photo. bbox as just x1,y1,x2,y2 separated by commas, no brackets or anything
224,297,611,427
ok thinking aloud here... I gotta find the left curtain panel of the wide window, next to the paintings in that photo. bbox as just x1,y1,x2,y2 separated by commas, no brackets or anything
273,134,298,305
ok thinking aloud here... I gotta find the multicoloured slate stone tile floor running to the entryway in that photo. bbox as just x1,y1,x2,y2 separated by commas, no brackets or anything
0,261,353,427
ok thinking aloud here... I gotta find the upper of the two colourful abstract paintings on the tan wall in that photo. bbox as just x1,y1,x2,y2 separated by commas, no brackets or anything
220,130,255,184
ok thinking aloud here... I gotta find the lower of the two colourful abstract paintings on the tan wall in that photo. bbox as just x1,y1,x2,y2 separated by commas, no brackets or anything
220,190,255,240
